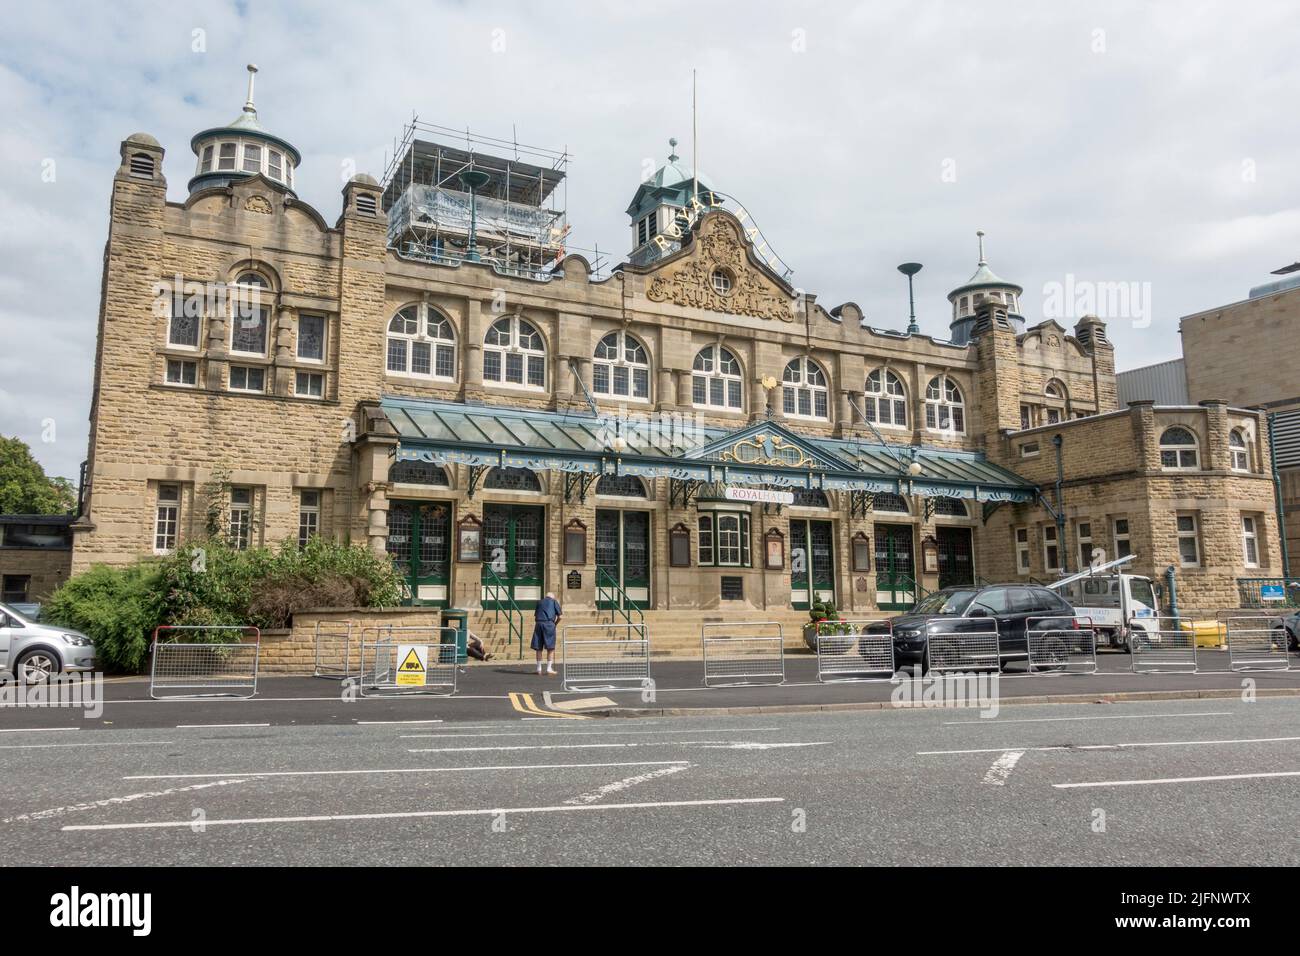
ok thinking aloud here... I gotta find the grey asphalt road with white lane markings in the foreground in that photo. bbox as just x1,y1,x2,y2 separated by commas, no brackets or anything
0,697,1300,868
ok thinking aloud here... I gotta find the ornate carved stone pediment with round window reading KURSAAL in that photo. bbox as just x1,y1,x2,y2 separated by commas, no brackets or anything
646,215,797,323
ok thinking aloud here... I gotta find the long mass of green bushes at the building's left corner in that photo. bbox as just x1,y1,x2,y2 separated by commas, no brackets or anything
43,537,402,671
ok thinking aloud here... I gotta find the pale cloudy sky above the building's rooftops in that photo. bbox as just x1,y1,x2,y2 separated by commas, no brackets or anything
0,0,1300,477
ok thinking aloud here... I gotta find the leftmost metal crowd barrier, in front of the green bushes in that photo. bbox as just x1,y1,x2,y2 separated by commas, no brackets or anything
150,624,261,700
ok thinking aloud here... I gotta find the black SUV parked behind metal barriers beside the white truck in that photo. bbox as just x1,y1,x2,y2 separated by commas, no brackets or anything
893,584,1075,672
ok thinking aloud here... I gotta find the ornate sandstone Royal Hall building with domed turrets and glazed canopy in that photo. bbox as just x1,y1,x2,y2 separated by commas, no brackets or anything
74,69,1279,613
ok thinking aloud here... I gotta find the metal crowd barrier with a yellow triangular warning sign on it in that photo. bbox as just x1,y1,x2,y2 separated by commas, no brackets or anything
358,626,460,697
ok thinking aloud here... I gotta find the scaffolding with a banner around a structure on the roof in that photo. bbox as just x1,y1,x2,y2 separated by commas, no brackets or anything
384,117,603,281
